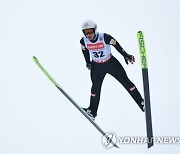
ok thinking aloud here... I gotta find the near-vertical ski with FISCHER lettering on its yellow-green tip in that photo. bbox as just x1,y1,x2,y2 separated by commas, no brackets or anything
137,31,154,148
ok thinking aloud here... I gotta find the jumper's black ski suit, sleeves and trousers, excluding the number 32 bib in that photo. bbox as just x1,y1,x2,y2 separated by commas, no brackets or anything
80,33,143,117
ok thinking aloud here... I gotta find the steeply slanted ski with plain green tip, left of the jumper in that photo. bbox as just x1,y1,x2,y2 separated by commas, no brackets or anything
33,56,119,148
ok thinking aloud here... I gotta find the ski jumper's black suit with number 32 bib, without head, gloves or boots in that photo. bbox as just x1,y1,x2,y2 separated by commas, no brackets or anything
80,33,143,116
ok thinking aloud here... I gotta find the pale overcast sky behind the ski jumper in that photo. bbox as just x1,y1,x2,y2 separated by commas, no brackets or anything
0,0,180,154
